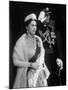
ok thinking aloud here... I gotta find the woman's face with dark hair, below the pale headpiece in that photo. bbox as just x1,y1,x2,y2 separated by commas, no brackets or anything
27,21,37,35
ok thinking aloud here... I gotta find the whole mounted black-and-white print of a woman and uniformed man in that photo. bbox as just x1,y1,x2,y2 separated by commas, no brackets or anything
9,1,66,89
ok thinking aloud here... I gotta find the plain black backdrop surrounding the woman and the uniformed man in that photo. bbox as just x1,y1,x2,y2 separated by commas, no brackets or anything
9,1,66,88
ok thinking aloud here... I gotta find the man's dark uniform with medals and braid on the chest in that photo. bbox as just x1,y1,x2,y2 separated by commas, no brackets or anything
39,20,62,86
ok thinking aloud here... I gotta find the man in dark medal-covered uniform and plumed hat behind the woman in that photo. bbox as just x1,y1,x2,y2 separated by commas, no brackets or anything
38,7,63,86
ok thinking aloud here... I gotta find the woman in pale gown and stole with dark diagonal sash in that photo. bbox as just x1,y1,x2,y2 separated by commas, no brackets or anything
13,13,50,88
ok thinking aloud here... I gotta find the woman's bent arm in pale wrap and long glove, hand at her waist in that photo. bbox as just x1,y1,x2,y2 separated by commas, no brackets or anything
13,45,38,69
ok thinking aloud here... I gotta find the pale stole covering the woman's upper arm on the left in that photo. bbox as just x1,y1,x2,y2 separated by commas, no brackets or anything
13,39,24,65
